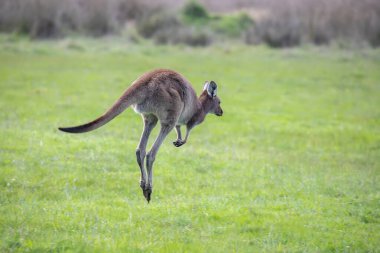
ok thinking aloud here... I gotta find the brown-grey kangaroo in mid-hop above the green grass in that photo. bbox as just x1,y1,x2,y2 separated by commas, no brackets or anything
59,69,223,202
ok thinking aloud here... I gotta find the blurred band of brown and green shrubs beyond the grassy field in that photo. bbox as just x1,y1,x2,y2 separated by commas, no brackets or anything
0,0,380,47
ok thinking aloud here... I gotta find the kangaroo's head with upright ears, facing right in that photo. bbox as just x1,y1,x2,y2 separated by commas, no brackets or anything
201,81,223,116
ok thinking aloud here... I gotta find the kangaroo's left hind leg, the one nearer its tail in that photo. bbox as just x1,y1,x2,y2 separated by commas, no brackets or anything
136,114,158,191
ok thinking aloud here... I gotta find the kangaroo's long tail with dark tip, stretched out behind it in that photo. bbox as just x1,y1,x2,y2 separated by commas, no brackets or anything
58,89,141,133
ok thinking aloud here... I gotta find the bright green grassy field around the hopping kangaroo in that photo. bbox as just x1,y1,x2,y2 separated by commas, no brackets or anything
0,36,380,252
